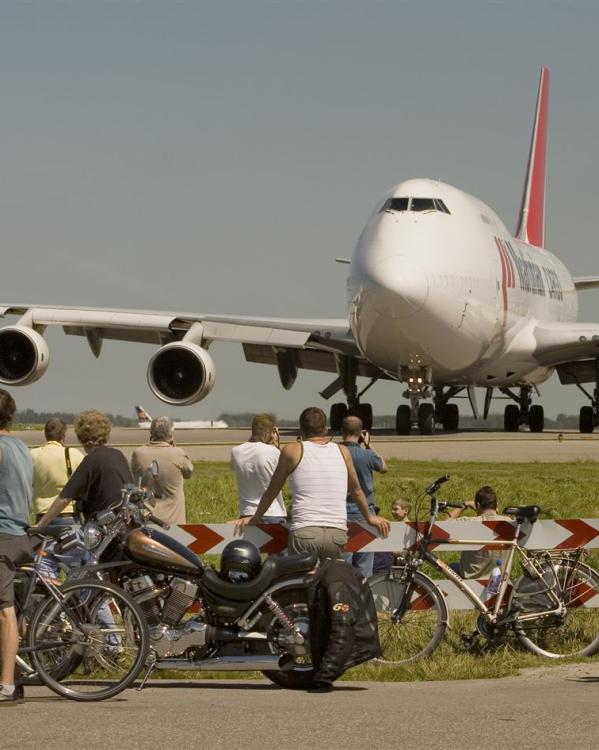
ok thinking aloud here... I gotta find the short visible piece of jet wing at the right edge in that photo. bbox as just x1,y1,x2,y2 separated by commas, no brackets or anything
534,322,599,384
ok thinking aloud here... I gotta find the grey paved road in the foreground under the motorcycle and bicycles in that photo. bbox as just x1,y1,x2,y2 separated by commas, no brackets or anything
0,662,599,750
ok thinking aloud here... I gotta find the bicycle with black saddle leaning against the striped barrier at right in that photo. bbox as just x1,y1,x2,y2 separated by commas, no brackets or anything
368,475,599,665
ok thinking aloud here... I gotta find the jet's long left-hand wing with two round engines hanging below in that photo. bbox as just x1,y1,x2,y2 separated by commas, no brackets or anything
0,304,389,405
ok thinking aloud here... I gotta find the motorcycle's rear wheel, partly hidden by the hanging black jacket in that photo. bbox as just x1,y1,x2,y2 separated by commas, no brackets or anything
262,588,314,690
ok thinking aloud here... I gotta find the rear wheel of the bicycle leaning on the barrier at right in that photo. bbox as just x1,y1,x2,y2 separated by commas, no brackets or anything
514,557,599,659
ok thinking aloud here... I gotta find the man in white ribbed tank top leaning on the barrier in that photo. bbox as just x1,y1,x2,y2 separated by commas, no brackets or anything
236,406,390,559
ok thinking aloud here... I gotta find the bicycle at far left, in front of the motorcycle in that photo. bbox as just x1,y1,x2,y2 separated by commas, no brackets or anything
17,528,150,701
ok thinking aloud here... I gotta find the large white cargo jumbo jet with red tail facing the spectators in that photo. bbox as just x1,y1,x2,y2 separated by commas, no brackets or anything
0,68,599,435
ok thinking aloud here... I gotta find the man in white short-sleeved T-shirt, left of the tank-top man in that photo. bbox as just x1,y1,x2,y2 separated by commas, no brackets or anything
231,414,287,523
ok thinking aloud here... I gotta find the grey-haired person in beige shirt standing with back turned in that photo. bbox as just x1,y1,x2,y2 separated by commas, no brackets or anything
131,417,193,524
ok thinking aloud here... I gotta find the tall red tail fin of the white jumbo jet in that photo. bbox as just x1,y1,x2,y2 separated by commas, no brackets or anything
516,68,549,247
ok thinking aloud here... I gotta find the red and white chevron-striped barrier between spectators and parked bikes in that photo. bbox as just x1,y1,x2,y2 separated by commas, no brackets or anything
161,518,599,610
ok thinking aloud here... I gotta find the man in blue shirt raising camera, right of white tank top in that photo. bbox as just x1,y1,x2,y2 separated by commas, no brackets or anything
341,417,387,578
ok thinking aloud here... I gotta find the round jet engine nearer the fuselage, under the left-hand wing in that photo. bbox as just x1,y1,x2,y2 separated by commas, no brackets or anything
148,341,216,406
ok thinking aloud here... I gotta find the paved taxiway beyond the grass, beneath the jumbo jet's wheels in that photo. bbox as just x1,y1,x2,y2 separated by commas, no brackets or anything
15,427,599,462
